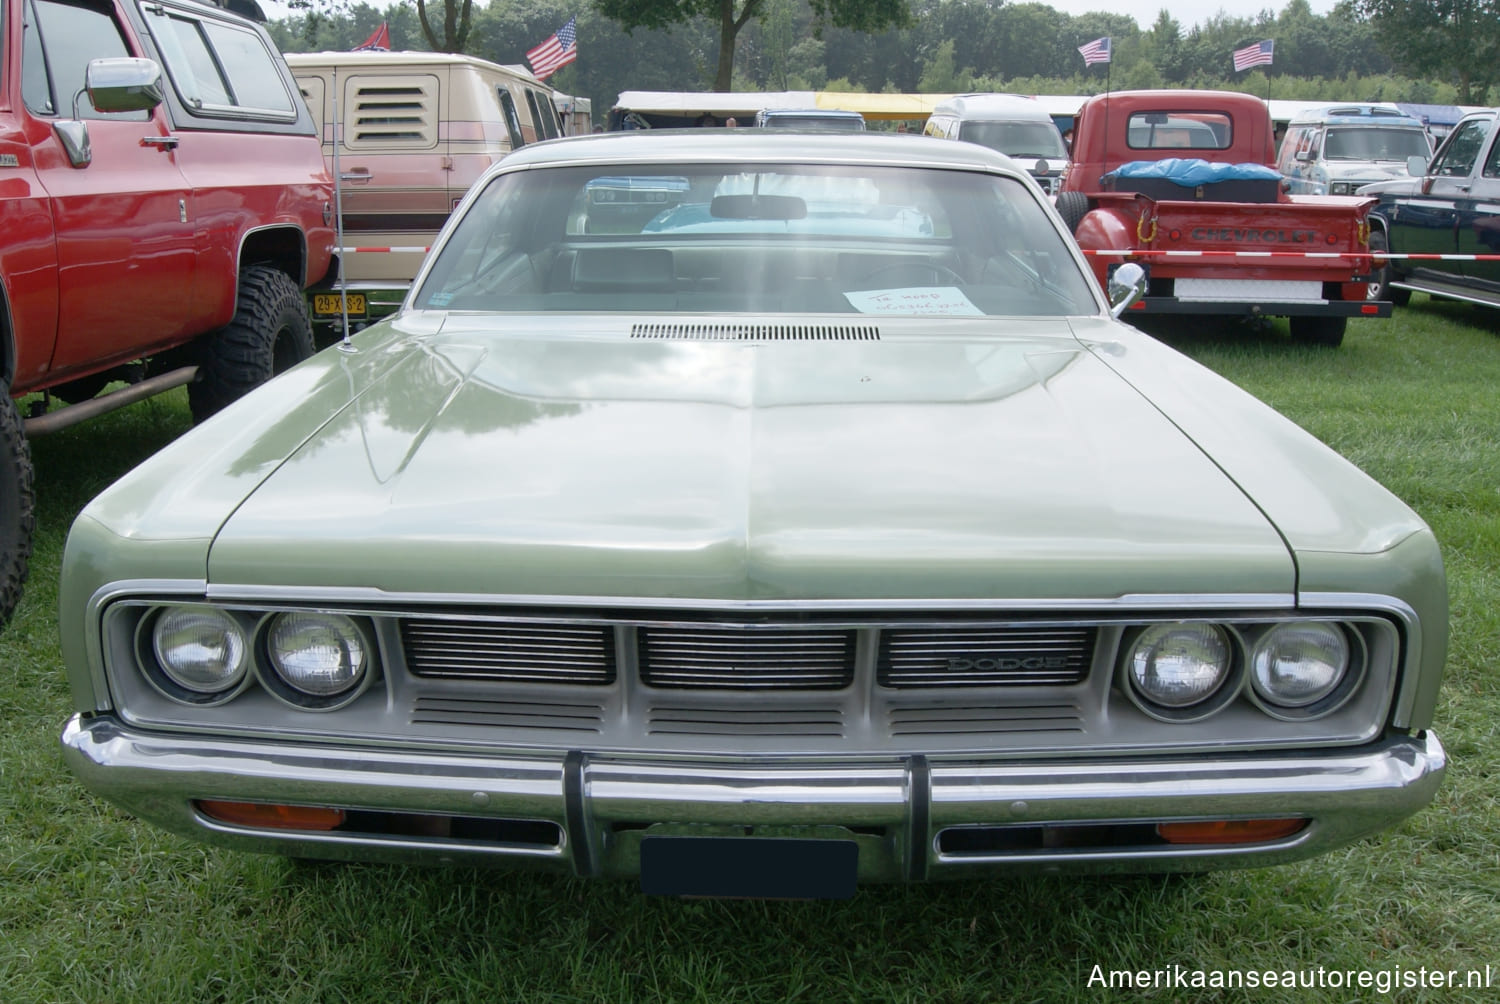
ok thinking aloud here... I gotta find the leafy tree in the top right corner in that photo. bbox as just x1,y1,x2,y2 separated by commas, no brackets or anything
1356,0,1500,105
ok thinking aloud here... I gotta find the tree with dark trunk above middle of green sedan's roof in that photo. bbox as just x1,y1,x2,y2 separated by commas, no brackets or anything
591,0,911,90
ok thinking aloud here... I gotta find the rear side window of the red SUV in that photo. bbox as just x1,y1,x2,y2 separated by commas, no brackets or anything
143,5,297,119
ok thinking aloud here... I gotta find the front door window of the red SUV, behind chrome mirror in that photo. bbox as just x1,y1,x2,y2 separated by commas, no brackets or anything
21,0,150,122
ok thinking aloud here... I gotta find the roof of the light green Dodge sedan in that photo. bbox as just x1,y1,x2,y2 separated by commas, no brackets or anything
497,128,1025,176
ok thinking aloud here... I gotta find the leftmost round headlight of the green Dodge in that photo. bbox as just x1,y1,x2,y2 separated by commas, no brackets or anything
152,605,249,702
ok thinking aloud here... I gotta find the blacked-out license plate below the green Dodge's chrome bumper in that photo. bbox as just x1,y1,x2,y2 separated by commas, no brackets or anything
641,836,860,899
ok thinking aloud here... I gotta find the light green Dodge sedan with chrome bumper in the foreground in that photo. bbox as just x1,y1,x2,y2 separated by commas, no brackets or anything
62,129,1448,897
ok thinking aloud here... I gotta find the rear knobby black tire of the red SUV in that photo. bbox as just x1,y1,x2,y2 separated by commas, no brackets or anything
188,266,314,422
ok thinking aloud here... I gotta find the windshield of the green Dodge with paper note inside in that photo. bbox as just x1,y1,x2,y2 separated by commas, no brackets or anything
413,164,1098,317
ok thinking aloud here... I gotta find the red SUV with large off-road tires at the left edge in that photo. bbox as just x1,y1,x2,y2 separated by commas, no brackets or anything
0,0,333,623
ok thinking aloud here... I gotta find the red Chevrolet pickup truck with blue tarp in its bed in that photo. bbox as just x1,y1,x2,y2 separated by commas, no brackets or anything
1058,90,1391,345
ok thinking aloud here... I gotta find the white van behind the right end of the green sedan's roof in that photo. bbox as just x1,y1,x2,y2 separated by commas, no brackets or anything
923,95,1068,195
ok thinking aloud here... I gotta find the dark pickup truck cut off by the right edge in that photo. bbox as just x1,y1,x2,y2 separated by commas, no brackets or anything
1359,108,1500,306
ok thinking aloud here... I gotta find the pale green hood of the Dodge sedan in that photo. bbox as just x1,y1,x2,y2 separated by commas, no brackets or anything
209,318,1295,602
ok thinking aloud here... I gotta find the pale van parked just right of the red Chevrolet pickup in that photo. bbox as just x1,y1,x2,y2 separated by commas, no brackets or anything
1277,105,1433,195
